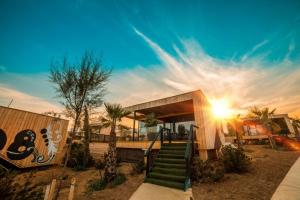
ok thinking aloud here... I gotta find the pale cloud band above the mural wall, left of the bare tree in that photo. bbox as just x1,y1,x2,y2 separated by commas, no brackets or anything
0,84,62,113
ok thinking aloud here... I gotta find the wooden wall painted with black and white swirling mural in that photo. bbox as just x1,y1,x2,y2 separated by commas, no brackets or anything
0,106,68,168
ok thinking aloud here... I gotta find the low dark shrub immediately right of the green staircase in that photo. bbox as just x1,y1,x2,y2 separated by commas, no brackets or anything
192,157,224,182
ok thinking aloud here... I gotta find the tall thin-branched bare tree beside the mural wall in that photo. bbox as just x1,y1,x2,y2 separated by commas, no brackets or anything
49,52,111,166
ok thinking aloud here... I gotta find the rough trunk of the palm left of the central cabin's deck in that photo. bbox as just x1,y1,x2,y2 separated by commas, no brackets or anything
104,120,117,182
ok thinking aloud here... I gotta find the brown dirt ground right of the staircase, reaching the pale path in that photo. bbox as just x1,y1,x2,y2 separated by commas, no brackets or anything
193,145,300,200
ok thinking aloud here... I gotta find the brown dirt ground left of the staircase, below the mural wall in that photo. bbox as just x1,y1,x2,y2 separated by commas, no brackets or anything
10,163,144,200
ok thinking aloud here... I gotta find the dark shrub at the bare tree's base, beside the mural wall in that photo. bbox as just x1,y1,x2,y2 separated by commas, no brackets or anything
67,143,94,170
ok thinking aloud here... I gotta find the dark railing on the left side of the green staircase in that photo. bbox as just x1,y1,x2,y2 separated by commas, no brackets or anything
145,127,171,176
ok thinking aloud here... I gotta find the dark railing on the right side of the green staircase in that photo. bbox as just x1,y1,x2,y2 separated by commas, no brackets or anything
184,124,198,190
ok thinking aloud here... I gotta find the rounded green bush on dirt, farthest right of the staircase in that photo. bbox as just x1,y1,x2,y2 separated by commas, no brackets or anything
221,146,251,173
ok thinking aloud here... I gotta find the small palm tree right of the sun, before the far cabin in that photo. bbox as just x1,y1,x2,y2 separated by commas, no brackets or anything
250,106,281,134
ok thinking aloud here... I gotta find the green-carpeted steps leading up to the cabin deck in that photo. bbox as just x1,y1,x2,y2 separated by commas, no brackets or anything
145,143,190,190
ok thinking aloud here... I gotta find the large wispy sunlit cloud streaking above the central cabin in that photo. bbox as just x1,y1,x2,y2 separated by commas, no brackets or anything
108,28,300,117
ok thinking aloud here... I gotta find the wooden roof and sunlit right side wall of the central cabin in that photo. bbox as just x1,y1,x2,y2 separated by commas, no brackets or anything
126,90,225,160
